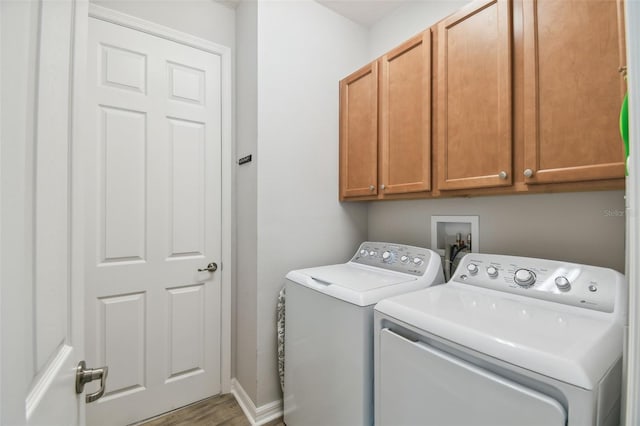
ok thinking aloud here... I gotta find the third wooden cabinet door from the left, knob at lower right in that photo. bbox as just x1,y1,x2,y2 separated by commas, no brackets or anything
436,0,512,190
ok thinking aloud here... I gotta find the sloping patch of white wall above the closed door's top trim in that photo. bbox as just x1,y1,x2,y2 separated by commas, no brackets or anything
90,0,235,50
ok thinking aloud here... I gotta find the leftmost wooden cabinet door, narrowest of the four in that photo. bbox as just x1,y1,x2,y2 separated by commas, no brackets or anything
340,62,378,200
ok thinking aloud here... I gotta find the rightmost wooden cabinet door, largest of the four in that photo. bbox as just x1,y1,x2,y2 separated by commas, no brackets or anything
523,0,624,183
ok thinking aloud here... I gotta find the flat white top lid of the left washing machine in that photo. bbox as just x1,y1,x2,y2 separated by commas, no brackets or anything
287,262,428,306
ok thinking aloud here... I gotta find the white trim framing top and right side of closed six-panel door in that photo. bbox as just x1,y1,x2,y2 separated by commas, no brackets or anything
89,4,234,393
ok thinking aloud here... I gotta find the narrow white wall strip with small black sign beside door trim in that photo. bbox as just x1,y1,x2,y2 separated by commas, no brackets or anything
232,1,258,401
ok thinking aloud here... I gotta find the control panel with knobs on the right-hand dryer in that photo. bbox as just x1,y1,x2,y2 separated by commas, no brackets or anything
451,253,627,312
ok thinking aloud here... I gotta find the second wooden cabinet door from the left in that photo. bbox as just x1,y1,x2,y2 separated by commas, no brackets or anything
380,30,431,195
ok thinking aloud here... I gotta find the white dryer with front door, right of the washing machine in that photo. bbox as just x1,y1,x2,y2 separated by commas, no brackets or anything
375,253,627,426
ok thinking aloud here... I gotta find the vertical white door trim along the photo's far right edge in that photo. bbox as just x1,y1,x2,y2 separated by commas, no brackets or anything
623,1,640,425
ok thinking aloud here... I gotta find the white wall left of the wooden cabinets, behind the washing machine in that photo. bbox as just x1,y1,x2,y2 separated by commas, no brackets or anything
252,0,367,406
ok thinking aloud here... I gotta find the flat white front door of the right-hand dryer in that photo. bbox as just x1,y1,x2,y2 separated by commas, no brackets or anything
376,329,567,426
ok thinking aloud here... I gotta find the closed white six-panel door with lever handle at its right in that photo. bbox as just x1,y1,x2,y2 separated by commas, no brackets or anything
86,18,221,424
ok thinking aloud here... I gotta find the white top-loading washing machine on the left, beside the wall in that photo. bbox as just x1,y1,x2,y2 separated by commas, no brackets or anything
284,242,444,426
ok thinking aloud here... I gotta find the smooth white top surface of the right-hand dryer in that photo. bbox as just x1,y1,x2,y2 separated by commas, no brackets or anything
375,282,623,390
